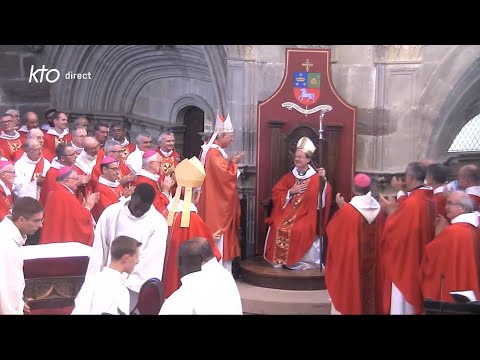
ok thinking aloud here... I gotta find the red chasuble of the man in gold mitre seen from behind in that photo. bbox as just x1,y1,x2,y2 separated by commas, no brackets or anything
162,211,221,298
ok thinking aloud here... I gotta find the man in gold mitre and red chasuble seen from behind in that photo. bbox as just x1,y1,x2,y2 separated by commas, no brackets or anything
162,157,221,298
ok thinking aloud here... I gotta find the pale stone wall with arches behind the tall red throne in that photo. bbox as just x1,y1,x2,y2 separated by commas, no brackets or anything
0,45,480,174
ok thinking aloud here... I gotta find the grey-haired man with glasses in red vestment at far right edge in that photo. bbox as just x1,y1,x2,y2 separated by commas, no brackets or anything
421,191,480,302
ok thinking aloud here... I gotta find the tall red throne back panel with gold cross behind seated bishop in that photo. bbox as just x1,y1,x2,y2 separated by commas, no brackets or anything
255,49,356,255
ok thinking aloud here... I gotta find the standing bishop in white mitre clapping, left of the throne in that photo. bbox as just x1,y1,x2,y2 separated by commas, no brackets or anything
198,114,244,272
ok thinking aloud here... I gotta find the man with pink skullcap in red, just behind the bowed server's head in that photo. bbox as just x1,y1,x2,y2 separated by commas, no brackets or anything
135,150,174,218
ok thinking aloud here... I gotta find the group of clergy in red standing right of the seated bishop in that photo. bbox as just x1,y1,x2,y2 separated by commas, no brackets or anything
325,160,480,315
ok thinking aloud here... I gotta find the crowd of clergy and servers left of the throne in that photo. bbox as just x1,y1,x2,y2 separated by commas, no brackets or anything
0,109,243,314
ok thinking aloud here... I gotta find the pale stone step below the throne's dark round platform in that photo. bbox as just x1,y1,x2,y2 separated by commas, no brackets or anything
237,280,331,315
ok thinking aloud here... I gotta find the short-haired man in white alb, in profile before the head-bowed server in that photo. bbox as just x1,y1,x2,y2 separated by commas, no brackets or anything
72,236,142,315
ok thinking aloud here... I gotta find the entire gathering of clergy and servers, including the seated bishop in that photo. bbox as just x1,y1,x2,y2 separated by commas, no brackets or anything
0,109,480,314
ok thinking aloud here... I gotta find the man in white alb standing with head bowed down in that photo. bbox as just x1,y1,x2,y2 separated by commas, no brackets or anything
87,184,168,307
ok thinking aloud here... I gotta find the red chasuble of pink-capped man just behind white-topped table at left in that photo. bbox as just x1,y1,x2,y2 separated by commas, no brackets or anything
39,183,93,246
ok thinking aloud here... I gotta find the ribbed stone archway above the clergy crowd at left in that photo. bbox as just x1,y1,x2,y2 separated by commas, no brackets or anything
43,45,227,124
